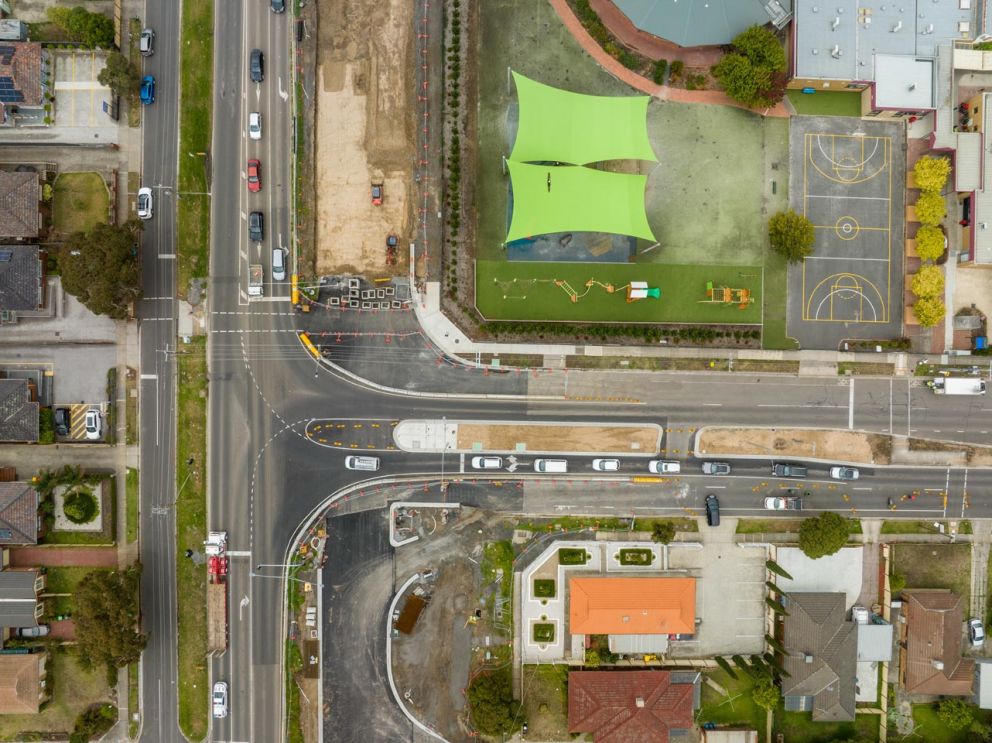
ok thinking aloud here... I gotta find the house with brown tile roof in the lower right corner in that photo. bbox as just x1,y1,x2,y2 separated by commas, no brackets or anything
899,589,975,696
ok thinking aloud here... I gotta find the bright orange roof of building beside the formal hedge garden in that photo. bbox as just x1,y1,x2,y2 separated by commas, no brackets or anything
568,578,696,635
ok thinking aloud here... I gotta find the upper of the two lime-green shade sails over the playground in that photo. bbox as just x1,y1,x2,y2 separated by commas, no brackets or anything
509,72,658,165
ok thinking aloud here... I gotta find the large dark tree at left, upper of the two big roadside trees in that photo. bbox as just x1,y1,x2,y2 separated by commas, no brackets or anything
59,219,143,320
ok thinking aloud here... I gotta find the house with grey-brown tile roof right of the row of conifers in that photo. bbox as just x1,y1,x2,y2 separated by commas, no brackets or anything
782,592,858,722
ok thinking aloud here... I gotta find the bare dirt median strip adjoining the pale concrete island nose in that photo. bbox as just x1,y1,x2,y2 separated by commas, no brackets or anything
457,423,661,454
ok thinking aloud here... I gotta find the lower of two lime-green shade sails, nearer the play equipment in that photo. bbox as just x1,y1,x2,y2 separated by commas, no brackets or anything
506,160,655,242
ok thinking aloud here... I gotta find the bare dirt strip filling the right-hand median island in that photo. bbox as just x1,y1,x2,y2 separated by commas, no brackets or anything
696,428,888,464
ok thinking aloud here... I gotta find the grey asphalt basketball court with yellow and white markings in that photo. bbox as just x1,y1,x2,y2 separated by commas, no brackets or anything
788,116,906,349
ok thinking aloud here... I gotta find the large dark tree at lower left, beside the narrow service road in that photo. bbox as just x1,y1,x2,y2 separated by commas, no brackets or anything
73,564,148,669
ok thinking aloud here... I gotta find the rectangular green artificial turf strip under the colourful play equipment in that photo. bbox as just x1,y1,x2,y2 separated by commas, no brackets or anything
476,261,762,325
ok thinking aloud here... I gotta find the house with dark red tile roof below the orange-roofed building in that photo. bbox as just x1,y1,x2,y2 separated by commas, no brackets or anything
568,671,700,743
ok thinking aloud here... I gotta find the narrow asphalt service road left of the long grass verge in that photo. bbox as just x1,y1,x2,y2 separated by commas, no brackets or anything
138,3,181,741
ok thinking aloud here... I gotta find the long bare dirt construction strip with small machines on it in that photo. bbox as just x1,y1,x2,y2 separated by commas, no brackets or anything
315,0,416,275
